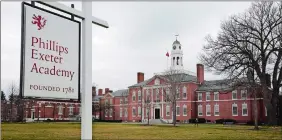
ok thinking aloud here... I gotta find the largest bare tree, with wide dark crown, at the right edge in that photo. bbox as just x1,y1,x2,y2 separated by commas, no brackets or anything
200,1,282,125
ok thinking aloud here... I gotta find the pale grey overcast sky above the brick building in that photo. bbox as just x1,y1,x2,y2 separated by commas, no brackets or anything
1,2,251,92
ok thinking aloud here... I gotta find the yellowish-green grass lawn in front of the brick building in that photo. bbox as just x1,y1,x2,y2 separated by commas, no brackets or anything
1,123,282,140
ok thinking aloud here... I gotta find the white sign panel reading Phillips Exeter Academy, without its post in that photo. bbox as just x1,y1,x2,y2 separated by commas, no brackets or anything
22,5,80,99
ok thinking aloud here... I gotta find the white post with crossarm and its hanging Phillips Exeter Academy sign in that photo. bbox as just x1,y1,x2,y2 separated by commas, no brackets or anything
20,1,109,139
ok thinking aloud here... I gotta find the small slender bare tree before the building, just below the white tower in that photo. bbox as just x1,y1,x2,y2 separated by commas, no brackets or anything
157,68,187,126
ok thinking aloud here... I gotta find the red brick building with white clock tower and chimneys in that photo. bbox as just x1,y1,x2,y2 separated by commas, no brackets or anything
100,40,267,123
